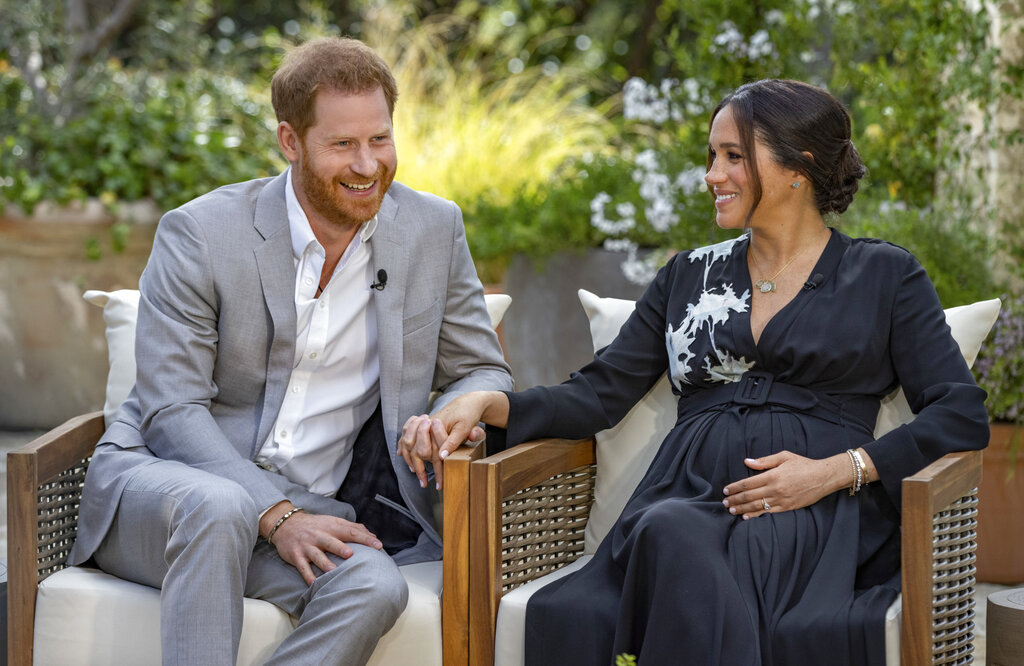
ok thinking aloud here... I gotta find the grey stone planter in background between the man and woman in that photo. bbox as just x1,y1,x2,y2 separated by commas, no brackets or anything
502,249,645,390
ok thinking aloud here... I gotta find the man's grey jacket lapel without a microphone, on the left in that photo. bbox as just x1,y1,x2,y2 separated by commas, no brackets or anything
252,172,296,456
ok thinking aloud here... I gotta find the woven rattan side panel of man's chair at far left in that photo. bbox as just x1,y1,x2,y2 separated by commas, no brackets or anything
36,458,91,582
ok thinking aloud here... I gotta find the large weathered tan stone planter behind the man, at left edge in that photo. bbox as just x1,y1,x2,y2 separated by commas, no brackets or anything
0,201,156,429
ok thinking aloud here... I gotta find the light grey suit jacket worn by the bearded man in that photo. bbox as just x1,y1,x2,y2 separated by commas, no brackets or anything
70,174,512,564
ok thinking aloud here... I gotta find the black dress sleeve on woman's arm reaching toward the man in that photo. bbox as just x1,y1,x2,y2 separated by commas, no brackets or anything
508,255,679,446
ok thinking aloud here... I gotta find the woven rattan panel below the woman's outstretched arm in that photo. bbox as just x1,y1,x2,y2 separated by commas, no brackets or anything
502,464,597,592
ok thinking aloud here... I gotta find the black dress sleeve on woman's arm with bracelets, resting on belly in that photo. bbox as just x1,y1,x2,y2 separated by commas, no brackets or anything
863,250,988,510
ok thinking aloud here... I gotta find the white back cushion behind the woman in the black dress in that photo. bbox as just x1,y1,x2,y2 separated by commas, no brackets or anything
579,289,1000,553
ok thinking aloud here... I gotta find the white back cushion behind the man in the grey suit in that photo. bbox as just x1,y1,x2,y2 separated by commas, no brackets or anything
82,289,512,425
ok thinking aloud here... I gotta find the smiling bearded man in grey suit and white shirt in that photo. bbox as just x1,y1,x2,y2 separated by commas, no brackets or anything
71,39,511,664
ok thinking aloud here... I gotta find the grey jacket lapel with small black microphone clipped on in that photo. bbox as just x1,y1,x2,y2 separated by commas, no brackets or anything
370,189,409,448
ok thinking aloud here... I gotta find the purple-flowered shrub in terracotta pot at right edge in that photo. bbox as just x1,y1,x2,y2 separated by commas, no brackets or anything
974,296,1024,424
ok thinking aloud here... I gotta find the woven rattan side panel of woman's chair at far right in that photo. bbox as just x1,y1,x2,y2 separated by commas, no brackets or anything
932,491,978,664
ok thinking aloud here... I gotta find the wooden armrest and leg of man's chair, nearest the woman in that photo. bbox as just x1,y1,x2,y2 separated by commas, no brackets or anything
441,445,484,666
